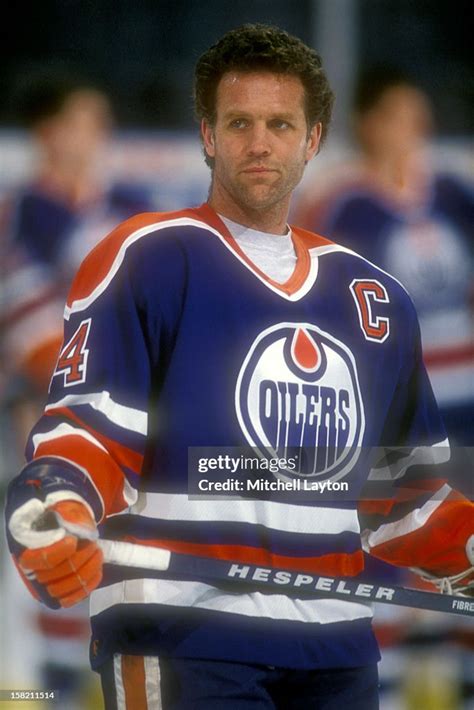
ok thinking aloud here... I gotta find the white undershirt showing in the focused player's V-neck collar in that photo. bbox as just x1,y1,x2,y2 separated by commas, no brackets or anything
219,215,296,283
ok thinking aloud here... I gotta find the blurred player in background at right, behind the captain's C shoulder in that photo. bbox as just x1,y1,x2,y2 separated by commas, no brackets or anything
295,65,474,446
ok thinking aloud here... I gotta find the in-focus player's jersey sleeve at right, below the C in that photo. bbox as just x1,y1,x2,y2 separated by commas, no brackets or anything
359,306,474,577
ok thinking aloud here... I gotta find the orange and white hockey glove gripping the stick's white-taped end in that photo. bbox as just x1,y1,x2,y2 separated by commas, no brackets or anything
8,491,103,608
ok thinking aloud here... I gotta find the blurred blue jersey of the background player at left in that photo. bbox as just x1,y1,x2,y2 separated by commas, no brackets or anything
0,182,151,401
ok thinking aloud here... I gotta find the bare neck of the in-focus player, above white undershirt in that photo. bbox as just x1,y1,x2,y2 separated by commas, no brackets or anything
208,186,290,234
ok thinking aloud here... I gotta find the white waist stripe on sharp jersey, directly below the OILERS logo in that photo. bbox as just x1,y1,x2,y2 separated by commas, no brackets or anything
130,492,360,535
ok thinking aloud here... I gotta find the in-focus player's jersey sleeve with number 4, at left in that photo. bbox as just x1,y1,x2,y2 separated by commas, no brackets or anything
7,218,182,521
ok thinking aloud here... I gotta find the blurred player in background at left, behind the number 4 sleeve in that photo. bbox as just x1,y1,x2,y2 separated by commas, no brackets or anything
0,67,151,707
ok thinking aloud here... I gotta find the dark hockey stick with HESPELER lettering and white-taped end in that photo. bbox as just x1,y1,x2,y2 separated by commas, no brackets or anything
98,540,474,616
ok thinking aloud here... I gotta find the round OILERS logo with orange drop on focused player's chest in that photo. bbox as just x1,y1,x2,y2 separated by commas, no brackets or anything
235,323,365,480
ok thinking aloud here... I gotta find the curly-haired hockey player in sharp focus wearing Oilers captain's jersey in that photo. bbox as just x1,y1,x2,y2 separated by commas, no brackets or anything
7,25,474,710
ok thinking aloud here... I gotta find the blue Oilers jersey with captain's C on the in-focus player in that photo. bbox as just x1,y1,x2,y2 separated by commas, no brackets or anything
9,205,468,668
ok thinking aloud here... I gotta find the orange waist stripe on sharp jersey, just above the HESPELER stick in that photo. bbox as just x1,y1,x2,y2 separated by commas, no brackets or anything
122,535,364,576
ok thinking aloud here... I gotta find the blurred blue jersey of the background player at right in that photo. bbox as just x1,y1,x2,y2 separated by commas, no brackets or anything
299,174,474,445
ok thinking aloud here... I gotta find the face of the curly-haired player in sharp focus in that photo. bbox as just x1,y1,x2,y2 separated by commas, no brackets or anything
202,71,321,220
